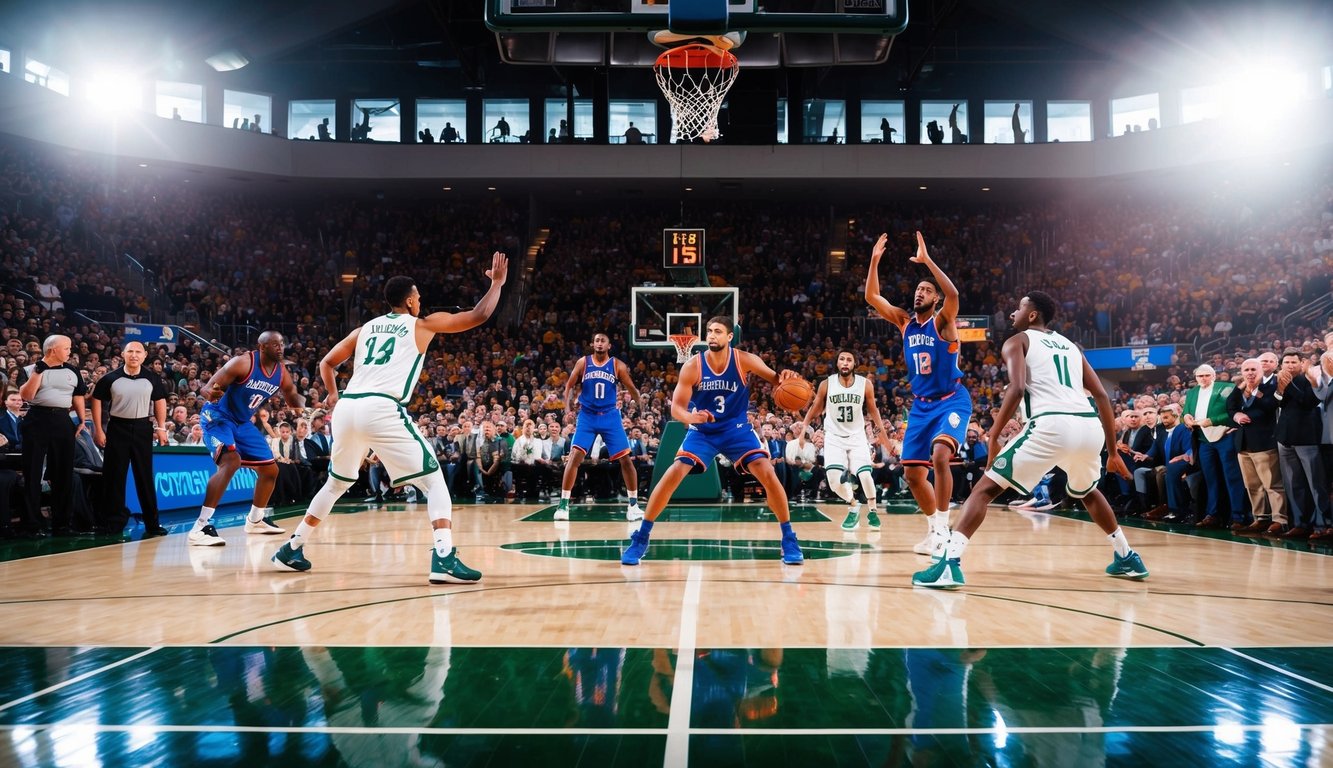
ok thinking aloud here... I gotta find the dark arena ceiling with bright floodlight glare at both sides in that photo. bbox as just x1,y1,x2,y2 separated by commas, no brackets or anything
0,0,1333,93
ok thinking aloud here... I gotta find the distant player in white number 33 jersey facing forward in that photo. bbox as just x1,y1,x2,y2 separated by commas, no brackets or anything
797,349,889,531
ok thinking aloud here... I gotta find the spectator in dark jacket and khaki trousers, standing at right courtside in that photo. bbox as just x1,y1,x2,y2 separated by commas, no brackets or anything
1226,357,1288,533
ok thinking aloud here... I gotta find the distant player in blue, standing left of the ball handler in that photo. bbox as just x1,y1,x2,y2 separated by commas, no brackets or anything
556,333,644,521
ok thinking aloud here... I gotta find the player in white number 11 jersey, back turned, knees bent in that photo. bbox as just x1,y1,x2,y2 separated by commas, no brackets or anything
912,291,1148,589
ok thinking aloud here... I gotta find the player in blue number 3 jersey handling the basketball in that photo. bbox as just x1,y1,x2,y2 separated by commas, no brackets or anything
620,317,805,565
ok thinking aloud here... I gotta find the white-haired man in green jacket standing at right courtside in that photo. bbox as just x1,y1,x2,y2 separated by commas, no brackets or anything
1182,363,1249,528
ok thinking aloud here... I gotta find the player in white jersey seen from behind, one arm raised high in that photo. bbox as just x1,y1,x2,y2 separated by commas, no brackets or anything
273,251,509,584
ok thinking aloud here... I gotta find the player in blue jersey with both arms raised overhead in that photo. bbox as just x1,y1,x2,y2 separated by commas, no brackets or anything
865,232,972,555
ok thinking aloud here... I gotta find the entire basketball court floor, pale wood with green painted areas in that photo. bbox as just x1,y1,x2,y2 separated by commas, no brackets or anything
0,504,1333,765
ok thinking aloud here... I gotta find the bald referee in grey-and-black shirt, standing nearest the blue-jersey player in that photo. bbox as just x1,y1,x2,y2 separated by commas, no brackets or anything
92,341,168,539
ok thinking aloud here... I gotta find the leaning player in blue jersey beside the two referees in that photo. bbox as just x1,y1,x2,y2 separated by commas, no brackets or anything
188,331,305,547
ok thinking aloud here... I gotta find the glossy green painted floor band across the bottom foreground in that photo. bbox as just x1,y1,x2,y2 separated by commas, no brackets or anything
0,645,1333,767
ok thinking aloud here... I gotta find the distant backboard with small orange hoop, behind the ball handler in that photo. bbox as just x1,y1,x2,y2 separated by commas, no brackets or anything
627,285,741,355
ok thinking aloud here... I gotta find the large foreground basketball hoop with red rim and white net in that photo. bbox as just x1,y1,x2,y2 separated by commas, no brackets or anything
653,43,741,141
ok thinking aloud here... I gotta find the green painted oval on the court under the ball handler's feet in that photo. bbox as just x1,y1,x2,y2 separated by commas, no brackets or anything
500,536,874,560
